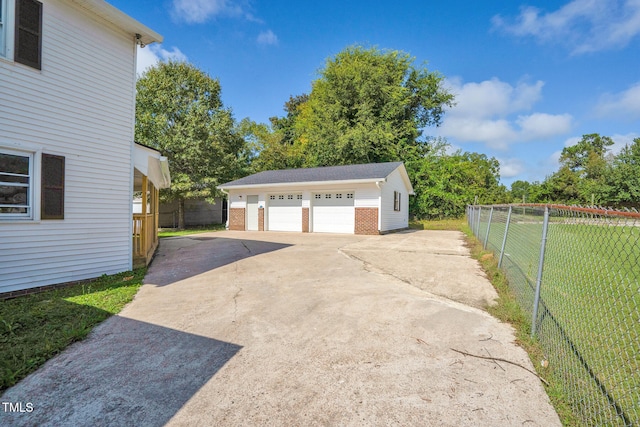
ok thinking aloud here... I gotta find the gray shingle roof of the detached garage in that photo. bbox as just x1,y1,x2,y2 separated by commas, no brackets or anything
219,162,402,188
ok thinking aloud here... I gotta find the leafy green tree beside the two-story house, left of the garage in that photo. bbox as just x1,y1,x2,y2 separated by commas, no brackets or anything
135,61,248,228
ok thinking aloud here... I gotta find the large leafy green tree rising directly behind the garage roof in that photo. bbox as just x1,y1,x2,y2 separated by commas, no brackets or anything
295,46,453,166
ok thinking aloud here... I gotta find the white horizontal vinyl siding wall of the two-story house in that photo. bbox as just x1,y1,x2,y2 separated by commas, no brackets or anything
0,0,135,292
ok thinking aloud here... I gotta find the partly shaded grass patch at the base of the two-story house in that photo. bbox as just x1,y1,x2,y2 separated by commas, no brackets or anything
0,269,146,393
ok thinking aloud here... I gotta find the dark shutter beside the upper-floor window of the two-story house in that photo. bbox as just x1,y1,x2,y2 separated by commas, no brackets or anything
13,0,42,70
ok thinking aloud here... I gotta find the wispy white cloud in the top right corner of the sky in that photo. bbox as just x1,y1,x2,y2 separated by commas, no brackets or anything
492,0,640,54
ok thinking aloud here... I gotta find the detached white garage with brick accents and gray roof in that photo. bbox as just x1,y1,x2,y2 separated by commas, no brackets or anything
218,162,413,234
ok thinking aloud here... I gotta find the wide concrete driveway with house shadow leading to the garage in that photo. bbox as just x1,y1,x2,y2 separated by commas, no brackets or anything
0,231,560,426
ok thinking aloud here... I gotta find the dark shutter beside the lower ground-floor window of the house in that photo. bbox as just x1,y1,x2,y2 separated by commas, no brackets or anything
40,154,64,219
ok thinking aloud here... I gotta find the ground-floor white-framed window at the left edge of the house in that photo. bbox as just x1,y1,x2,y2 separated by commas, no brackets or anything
0,150,34,219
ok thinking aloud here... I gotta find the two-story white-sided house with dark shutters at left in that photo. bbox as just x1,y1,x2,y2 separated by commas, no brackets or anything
0,0,168,296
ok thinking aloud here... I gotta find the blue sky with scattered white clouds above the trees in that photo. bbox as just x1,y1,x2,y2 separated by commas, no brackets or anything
109,0,640,185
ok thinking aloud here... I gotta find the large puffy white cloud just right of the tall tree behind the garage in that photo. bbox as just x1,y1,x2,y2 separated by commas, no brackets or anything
438,78,573,150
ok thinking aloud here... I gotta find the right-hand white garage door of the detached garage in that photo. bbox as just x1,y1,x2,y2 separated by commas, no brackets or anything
311,191,355,234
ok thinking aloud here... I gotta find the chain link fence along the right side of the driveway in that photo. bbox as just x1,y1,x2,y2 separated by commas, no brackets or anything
467,204,640,426
